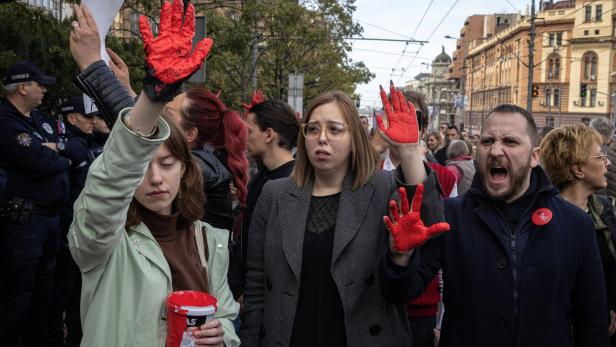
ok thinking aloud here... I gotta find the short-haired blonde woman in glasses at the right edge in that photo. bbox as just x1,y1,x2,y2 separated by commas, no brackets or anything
541,124,616,346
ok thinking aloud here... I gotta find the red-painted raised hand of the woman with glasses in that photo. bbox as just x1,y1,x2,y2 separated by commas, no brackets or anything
376,81,419,144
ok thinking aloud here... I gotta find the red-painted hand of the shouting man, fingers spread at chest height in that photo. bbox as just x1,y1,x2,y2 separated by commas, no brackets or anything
383,184,449,253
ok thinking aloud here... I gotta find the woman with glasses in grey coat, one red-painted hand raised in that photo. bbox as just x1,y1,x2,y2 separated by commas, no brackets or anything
241,85,443,346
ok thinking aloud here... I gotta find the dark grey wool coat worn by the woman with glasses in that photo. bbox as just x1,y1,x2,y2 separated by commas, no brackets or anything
241,167,444,346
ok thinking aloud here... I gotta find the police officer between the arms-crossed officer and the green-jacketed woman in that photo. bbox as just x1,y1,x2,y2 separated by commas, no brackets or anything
49,95,102,346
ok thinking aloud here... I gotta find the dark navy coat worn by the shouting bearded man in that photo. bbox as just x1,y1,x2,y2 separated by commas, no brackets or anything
410,167,608,347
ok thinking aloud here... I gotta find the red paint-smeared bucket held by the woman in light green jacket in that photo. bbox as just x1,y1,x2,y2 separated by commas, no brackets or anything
167,290,218,347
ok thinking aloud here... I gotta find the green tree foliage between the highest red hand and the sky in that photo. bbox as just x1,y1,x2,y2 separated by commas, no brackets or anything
207,0,374,105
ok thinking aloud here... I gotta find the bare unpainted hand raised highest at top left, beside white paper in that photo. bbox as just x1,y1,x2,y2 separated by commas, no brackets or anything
69,5,101,71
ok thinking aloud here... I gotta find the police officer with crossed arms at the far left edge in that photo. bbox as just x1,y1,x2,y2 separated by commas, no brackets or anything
0,62,71,346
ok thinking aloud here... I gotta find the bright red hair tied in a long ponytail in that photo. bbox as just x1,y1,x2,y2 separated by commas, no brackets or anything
181,88,248,206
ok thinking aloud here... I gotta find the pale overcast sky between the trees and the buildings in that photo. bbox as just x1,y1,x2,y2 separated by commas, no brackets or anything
349,0,539,108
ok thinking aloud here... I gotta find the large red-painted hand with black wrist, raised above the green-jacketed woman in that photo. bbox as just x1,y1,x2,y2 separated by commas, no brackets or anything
139,0,213,100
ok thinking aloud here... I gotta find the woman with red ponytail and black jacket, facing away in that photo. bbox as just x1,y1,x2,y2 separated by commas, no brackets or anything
165,88,248,230
